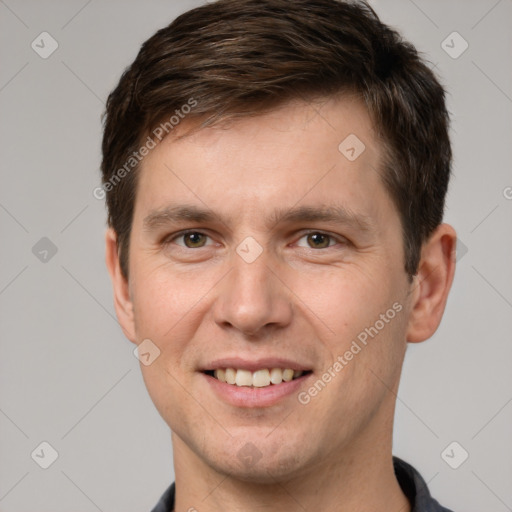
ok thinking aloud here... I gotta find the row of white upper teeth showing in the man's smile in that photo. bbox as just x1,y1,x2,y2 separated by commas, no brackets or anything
203,368,311,388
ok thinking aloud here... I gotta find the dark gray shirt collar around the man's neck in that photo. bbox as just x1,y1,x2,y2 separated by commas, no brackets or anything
151,457,451,512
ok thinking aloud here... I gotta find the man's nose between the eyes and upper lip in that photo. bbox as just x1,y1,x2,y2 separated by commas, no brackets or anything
214,250,293,337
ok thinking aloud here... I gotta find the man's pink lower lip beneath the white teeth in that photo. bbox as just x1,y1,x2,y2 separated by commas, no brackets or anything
201,373,313,407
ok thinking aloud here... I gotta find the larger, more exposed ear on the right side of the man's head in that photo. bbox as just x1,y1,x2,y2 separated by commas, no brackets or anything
406,224,457,343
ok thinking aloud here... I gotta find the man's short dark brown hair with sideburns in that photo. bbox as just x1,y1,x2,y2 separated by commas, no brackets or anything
101,0,451,277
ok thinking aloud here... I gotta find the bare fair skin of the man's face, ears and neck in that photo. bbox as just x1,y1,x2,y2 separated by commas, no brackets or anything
106,97,456,512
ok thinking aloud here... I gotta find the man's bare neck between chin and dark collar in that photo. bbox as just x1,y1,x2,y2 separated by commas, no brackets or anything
173,414,411,512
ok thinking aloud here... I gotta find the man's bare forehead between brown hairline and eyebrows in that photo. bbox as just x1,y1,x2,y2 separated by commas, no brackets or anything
136,98,390,228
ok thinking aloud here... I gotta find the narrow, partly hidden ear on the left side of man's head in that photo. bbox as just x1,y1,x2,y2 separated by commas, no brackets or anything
105,228,136,343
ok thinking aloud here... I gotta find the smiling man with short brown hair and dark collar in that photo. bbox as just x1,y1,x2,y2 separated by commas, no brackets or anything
102,0,456,512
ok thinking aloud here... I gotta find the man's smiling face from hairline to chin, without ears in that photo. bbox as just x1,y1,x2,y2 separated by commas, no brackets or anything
119,98,410,482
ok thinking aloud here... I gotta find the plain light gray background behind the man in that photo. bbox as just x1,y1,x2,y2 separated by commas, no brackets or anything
0,0,512,512
